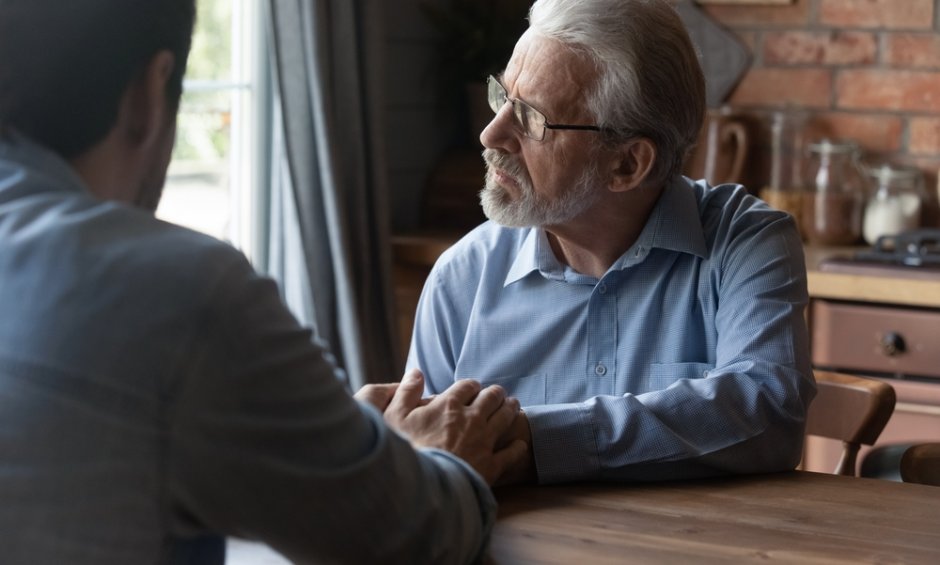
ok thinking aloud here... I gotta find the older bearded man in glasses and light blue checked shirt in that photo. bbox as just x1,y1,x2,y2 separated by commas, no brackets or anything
409,0,815,483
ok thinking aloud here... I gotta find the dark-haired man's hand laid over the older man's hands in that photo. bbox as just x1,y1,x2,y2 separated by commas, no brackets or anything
382,369,528,485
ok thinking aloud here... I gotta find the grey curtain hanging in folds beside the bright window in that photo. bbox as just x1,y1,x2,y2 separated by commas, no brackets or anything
268,0,400,390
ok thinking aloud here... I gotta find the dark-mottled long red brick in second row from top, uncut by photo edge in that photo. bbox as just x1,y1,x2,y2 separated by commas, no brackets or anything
764,31,878,65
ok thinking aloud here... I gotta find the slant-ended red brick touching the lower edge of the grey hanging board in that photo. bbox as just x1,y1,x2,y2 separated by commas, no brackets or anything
729,68,832,108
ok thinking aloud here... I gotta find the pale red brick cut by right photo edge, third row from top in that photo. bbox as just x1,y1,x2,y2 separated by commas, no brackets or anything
836,70,940,112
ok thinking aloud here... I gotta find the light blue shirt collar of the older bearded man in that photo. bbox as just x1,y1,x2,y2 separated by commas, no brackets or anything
504,176,708,286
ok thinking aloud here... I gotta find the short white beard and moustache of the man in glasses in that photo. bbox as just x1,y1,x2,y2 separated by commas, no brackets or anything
480,149,601,228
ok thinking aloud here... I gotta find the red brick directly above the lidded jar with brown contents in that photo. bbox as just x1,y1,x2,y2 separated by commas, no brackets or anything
806,112,903,153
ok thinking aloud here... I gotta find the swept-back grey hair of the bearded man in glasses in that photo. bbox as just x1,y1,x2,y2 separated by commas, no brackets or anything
529,0,705,187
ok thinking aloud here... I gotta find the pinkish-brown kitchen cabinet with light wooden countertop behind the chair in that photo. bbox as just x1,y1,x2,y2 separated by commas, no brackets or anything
803,249,940,472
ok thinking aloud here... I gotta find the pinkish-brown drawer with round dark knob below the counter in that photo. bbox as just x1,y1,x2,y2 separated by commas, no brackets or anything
810,299,940,378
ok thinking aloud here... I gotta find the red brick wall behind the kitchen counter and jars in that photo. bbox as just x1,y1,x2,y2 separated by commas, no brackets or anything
701,0,940,205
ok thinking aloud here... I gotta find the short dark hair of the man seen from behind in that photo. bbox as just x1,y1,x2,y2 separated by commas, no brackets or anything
0,0,196,158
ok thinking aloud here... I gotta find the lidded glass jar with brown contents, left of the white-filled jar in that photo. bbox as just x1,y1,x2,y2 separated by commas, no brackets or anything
801,139,867,245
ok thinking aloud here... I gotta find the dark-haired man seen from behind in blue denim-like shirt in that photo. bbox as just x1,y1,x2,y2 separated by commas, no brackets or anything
0,0,525,565
